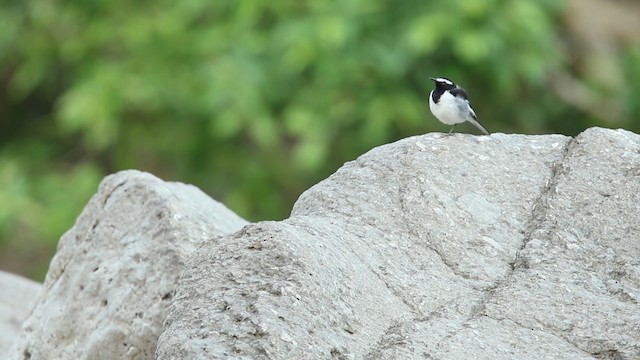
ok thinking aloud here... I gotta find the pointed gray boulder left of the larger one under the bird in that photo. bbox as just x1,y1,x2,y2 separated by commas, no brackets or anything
8,171,246,359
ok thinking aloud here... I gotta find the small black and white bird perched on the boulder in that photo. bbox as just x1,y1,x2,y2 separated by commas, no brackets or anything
429,78,489,135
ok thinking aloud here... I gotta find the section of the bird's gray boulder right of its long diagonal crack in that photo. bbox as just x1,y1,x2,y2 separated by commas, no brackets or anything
482,129,640,360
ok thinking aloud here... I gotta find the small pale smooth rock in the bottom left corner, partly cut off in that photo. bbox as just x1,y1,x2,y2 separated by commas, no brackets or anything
0,271,42,354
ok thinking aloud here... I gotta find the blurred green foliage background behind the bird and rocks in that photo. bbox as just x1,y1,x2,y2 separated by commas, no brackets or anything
0,0,640,280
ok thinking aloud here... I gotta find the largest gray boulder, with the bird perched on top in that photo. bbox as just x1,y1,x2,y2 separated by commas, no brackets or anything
156,128,640,359
